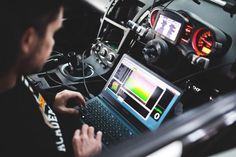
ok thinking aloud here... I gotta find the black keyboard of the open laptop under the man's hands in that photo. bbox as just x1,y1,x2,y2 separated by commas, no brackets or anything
81,99,134,145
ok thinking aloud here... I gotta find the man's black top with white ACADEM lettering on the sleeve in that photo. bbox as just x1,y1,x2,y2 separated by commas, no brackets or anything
0,79,65,157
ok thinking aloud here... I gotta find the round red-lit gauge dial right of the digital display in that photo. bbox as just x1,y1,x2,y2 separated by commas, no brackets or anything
192,28,214,56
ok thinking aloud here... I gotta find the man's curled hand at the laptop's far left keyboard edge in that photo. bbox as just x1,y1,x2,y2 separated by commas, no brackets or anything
54,90,85,114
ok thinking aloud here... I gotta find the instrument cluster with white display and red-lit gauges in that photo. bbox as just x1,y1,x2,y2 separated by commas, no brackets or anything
148,7,230,58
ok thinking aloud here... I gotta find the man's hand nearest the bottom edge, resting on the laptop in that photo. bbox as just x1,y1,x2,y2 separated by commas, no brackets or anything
72,124,102,157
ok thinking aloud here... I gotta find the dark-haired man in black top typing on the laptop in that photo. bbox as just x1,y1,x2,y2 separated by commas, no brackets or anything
0,0,102,157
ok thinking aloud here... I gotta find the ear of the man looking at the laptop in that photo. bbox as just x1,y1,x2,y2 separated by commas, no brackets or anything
21,27,38,55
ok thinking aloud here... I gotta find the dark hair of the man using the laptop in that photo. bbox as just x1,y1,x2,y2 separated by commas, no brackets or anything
0,0,62,76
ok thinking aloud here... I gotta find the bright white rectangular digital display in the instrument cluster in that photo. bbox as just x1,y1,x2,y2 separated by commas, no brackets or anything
155,14,181,42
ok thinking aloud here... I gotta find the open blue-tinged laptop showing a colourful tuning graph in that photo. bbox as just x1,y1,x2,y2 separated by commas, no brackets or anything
81,54,182,146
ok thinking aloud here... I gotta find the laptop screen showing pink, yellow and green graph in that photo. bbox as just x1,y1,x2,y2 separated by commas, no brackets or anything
104,55,182,130
